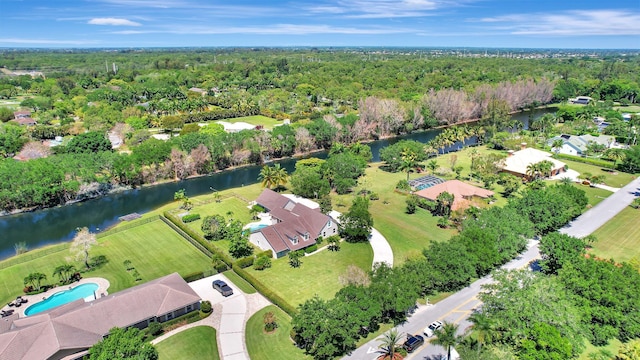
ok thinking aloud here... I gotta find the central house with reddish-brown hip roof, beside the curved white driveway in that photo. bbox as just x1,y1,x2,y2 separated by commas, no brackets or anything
249,189,338,258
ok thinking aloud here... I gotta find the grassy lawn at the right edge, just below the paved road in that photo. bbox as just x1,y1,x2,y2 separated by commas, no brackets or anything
590,207,640,262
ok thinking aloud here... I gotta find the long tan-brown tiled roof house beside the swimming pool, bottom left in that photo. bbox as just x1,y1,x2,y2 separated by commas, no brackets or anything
0,273,200,360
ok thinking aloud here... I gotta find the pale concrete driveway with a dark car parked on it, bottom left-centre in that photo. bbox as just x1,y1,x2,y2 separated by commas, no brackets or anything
151,274,271,360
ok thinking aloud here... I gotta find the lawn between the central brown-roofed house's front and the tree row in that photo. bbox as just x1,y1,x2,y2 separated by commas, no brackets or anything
245,242,373,306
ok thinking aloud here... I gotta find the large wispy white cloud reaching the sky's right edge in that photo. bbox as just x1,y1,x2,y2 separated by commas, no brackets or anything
477,10,640,36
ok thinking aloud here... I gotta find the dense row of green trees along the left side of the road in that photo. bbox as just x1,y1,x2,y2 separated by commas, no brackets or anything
292,184,586,359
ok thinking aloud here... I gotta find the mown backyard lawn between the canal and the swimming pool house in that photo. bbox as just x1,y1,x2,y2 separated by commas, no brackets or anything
0,220,211,304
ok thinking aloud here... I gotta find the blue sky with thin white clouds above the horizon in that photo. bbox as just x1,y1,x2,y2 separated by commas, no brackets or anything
0,0,640,49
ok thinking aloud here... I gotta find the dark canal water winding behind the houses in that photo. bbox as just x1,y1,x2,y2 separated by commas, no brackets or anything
0,109,554,260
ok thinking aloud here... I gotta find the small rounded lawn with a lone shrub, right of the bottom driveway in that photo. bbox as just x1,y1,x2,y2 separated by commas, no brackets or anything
245,304,311,360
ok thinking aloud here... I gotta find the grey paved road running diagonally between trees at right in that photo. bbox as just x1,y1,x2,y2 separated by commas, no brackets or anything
343,178,640,360
